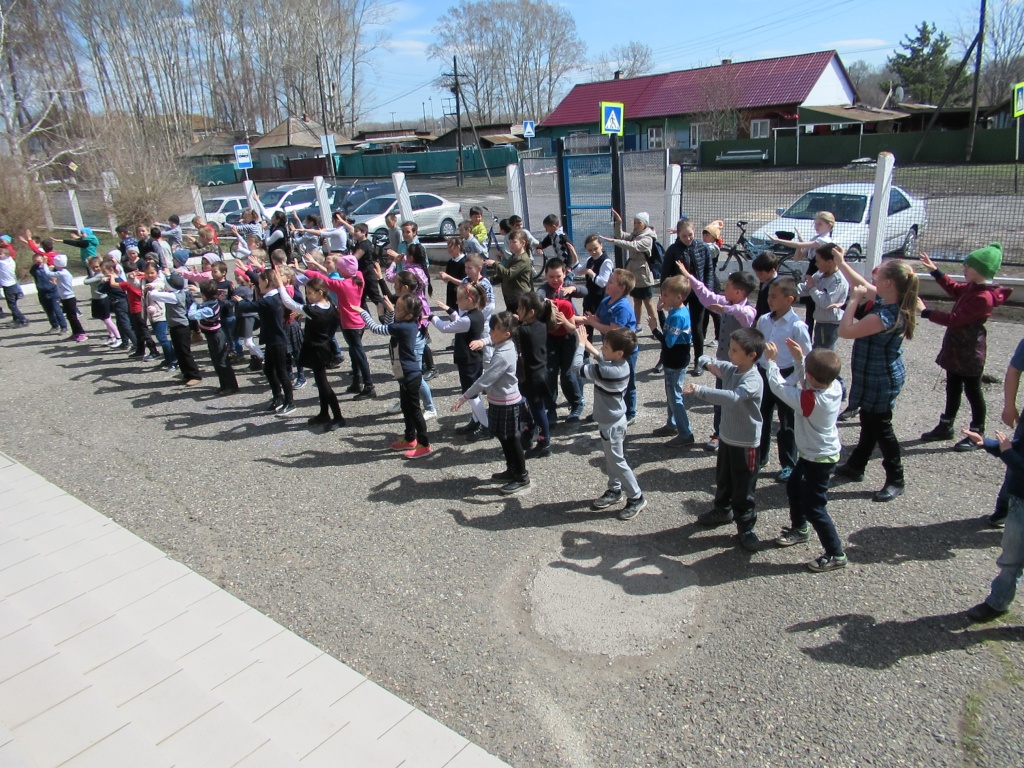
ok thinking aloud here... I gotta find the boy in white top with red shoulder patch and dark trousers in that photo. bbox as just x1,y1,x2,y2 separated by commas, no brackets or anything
764,339,846,572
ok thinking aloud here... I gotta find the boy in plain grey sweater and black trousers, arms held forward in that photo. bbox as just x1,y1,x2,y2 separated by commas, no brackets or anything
683,327,765,552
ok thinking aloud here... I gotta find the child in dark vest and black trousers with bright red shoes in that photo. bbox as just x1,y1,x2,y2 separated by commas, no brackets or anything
352,293,433,459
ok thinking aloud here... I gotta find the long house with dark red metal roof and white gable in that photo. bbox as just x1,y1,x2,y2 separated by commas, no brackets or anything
538,50,857,156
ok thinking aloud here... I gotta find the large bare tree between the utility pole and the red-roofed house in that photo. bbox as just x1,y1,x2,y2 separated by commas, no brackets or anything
427,0,585,123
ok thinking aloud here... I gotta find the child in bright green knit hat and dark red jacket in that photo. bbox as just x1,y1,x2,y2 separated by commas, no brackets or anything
921,243,1010,453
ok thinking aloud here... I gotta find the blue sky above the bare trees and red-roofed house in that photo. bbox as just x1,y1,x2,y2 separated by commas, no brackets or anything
364,0,966,126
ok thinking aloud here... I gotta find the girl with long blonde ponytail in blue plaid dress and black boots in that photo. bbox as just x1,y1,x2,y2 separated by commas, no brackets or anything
836,249,921,502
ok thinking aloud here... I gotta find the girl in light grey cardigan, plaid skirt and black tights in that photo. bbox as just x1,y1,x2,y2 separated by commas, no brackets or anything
460,311,529,496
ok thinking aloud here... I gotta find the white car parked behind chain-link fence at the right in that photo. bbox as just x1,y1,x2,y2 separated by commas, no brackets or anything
748,183,928,261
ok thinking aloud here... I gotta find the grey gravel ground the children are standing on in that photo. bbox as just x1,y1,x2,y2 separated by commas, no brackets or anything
0,286,1024,768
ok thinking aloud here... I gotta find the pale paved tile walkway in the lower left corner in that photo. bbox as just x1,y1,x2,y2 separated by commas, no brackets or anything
0,454,506,768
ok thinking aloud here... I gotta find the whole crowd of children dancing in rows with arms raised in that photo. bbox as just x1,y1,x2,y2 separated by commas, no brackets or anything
0,205,1024,589
